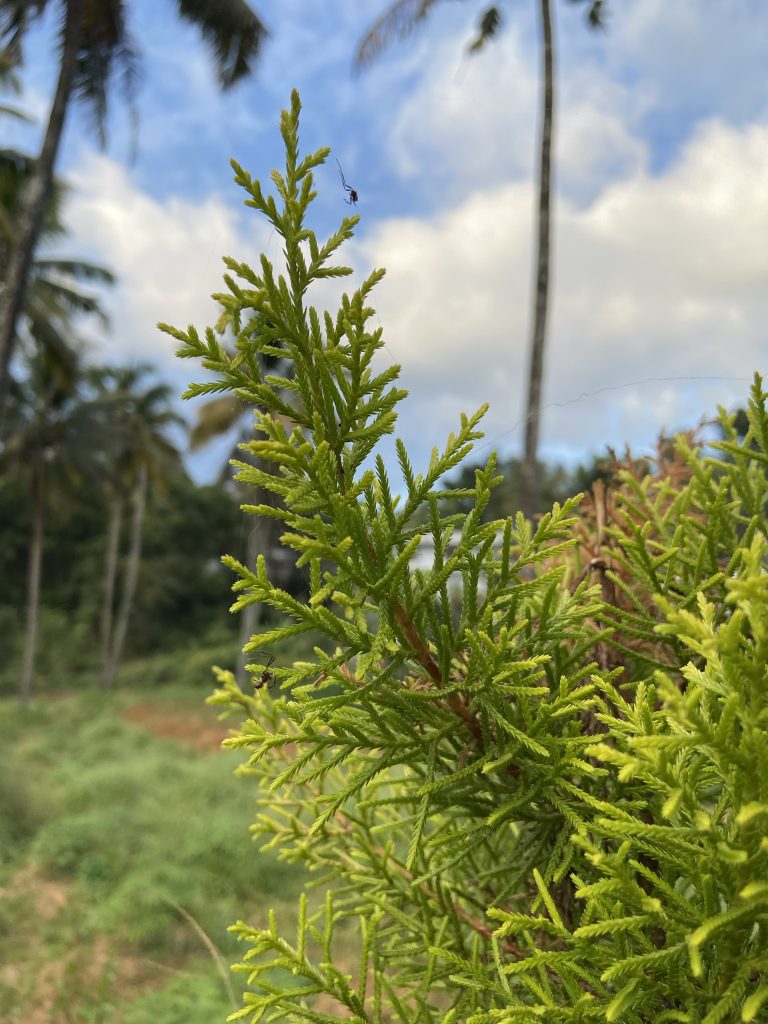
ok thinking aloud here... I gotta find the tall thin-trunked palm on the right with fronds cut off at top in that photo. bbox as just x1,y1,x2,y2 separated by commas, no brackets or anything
355,0,605,516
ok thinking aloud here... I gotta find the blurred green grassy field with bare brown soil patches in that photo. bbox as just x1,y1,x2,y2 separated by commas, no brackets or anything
0,667,304,1024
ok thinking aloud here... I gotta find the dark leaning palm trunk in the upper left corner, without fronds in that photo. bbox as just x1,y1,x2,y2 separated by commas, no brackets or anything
0,0,85,425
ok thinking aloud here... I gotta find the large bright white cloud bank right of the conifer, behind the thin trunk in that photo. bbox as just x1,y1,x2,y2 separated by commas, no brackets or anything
358,116,768,471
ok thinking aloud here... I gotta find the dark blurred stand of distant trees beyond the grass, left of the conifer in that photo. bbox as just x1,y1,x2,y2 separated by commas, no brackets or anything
0,354,239,701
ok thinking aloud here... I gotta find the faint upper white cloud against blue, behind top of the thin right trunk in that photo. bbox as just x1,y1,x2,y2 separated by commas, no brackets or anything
387,24,649,205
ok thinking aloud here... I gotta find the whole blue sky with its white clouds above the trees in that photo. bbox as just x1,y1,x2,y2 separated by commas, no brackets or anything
6,0,768,479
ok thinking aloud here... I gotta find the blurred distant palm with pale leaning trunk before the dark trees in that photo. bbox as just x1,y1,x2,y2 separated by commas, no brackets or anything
88,366,183,689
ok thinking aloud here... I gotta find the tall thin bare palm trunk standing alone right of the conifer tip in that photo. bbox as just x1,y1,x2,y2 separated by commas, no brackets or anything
520,0,555,517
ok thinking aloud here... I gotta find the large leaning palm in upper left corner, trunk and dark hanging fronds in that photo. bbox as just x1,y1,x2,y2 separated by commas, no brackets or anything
0,0,267,417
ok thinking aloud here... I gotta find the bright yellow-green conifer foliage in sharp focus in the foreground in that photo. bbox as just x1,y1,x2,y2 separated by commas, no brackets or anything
166,93,768,1024
